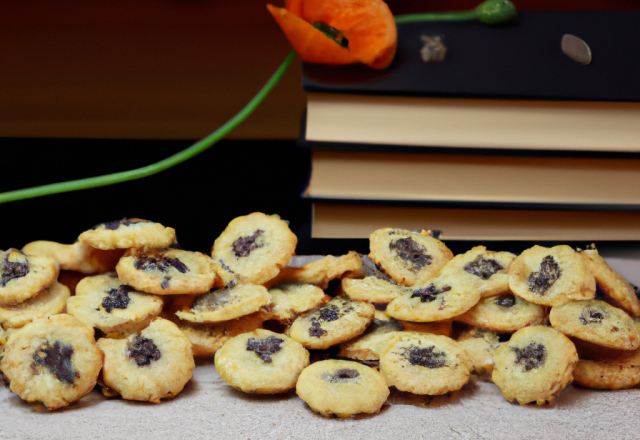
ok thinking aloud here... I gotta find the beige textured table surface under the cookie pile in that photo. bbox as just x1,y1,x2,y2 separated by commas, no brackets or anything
0,249,640,440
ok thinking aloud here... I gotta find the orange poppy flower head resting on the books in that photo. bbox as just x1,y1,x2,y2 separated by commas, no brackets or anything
267,0,398,69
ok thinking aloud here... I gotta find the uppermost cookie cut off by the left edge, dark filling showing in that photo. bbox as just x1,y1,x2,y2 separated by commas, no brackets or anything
0,248,60,307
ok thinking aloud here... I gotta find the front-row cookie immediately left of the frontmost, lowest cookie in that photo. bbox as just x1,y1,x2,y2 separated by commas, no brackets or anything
215,330,309,394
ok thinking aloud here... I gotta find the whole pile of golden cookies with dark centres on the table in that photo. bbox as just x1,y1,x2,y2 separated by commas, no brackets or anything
0,213,640,417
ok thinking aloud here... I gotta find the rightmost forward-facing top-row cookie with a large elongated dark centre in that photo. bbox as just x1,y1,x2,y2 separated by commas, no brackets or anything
509,245,596,307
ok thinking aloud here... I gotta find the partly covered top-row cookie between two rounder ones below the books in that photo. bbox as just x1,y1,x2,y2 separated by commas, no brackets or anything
441,246,516,298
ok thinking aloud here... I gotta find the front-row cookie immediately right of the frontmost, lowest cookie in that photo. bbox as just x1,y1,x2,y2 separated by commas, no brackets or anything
380,332,473,396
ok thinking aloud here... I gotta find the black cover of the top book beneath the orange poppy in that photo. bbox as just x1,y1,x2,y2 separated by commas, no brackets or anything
302,11,640,101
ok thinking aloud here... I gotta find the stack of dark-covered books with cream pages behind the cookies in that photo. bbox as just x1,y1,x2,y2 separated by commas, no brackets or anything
299,12,640,241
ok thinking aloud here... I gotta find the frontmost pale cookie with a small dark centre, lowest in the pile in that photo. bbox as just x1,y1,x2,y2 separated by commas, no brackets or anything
296,360,389,418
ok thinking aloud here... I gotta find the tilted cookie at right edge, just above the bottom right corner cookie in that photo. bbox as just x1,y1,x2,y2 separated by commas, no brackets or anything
549,299,640,350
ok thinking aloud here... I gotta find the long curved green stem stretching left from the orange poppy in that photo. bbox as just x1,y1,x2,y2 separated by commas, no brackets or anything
0,52,296,203
